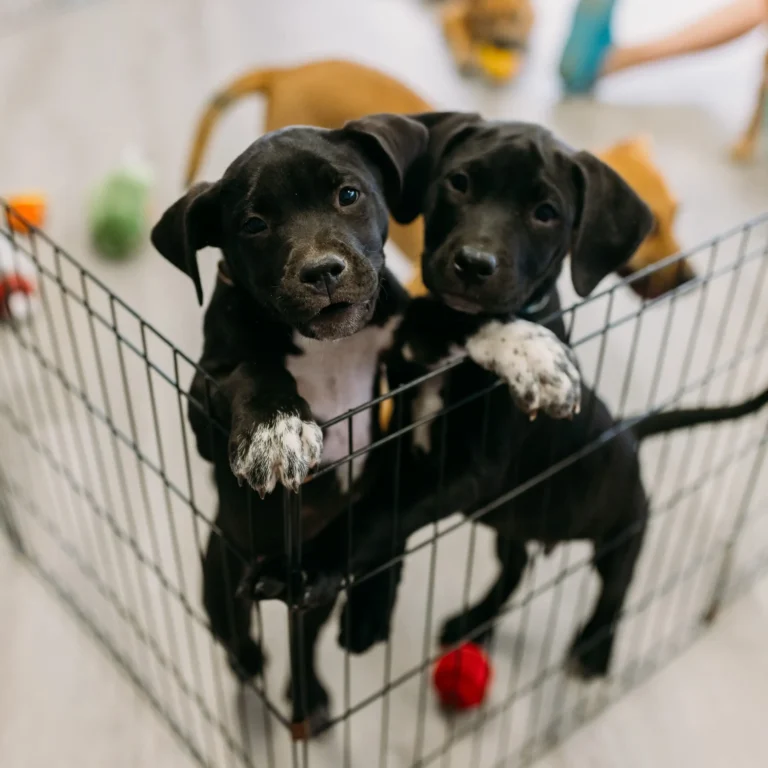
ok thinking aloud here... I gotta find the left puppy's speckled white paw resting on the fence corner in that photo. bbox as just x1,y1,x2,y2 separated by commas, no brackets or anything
230,413,323,499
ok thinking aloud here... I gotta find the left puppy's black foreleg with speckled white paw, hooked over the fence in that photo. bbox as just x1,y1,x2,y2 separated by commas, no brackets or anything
221,363,323,498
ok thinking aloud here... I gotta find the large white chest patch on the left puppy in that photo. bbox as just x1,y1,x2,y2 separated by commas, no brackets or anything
286,318,400,490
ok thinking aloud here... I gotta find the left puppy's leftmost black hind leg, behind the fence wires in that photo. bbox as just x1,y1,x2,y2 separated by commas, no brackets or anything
203,531,264,682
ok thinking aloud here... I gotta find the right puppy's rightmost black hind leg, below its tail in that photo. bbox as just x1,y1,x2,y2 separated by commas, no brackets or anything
567,510,648,680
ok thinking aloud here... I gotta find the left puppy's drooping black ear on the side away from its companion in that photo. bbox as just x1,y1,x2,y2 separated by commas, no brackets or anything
151,182,221,304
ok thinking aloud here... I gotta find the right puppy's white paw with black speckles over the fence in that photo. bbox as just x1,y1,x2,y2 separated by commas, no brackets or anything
466,320,581,419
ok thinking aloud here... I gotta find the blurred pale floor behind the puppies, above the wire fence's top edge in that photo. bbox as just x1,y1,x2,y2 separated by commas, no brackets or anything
0,0,766,344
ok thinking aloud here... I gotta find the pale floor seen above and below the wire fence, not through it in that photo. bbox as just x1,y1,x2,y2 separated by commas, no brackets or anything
0,0,768,768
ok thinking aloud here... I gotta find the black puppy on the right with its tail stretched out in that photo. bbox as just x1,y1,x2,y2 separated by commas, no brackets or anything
249,114,767,677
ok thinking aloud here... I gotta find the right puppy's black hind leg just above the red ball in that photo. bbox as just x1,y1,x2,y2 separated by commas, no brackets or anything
440,536,528,645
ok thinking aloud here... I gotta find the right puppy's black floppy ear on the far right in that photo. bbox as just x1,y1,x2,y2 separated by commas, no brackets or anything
571,152,653,296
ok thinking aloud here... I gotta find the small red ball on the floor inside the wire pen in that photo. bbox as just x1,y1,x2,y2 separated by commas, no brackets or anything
432,643,492,709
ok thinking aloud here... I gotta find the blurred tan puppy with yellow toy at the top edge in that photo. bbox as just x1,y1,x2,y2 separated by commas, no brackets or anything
443,0,533,83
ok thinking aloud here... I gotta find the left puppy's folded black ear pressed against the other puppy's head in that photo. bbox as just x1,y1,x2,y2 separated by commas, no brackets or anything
343,114,429,224
